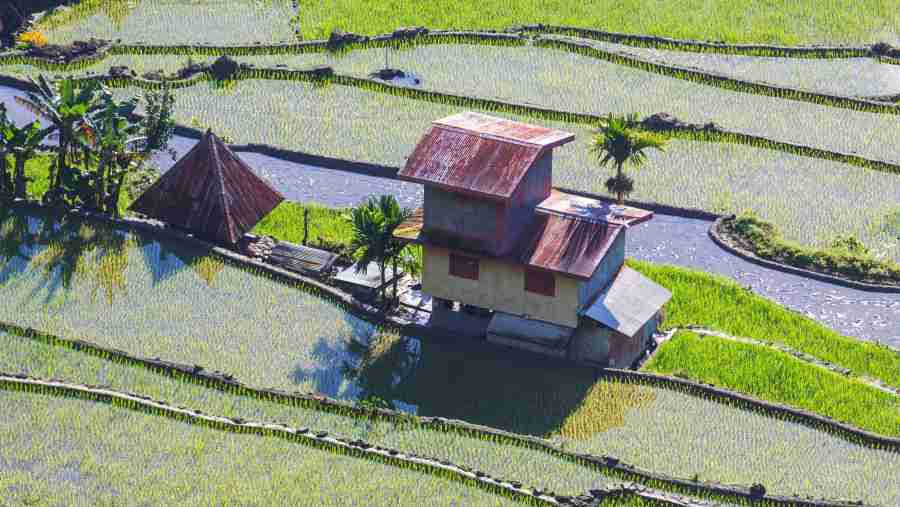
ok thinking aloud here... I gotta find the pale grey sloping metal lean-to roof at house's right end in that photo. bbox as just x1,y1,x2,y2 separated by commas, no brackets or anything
581,266,672,336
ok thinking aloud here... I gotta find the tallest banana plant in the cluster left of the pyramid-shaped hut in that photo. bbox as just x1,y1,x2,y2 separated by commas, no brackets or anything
16,74,99,202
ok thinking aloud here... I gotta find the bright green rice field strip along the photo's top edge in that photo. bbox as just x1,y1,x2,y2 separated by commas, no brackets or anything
298,0,900,44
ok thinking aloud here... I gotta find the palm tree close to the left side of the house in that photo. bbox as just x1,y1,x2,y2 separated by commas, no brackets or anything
350,195,412,310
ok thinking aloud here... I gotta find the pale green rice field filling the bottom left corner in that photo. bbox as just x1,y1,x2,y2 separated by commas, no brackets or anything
0,391,536,507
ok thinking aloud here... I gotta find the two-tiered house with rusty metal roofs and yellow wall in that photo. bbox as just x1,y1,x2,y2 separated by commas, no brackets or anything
395,112,671,366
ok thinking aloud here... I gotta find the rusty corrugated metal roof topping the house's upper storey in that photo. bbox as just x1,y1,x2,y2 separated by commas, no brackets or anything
397,113,575,200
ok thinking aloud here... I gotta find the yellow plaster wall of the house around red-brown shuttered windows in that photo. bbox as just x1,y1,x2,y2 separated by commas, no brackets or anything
422,245,578,327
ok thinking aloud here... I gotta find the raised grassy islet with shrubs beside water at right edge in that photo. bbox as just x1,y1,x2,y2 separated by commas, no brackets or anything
720,213,900,287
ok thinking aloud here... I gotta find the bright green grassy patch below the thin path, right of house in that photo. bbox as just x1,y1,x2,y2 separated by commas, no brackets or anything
644,331,900,436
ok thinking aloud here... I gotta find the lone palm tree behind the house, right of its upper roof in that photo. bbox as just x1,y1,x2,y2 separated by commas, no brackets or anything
590,114,666,206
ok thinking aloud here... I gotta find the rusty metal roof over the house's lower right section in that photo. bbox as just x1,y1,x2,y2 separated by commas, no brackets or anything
521,215,622,279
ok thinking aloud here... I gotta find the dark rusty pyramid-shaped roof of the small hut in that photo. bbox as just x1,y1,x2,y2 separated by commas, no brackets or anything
128,130,284,244
